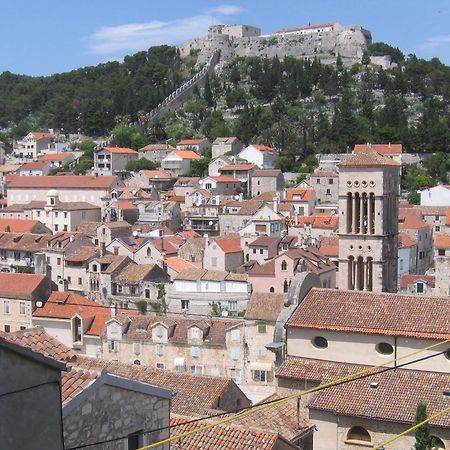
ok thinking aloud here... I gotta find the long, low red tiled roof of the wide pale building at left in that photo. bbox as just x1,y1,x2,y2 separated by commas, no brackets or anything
8,175,117,189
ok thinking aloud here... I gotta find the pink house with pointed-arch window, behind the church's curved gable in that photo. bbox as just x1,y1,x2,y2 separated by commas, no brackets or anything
248,247,337,294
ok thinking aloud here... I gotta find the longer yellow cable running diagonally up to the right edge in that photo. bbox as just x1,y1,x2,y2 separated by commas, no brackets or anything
138,339,450,450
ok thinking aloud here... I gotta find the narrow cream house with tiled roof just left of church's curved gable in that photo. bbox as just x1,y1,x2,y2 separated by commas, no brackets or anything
244,293,286,386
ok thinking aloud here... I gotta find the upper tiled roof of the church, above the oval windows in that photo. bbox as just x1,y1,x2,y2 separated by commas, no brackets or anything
287,288,450,339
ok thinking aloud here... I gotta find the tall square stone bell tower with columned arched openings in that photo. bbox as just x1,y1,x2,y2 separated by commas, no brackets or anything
338,147,400,292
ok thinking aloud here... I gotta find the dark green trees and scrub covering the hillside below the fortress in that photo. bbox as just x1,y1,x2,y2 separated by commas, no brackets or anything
0,43,450,185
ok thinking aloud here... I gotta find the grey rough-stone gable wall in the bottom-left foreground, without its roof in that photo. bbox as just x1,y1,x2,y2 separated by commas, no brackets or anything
63,384,170,450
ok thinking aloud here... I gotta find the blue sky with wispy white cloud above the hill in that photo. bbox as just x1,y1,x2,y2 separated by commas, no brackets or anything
0,0,450,75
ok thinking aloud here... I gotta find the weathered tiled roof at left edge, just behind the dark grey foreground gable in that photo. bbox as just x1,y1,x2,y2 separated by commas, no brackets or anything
0,327,77,362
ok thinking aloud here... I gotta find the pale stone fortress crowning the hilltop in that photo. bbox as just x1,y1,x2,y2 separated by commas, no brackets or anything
178,22,372,64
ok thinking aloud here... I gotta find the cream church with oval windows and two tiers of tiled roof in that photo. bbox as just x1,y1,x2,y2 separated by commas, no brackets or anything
277,288,450,450
